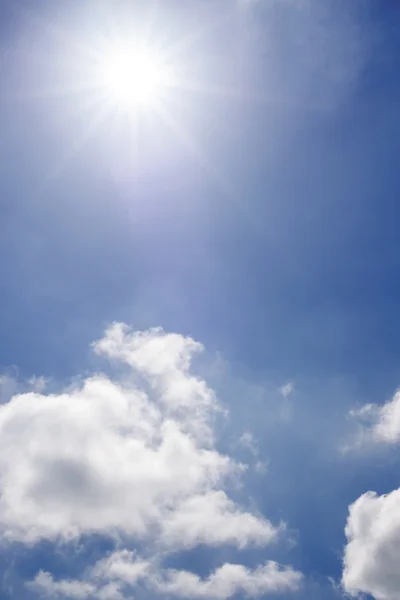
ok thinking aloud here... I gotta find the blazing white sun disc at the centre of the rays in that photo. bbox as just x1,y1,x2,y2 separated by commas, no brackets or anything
99,46,172,109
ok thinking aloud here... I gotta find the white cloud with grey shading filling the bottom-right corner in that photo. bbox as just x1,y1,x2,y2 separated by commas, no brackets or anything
343,489,400,600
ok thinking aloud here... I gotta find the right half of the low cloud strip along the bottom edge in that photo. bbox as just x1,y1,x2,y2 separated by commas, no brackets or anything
155,561,302,600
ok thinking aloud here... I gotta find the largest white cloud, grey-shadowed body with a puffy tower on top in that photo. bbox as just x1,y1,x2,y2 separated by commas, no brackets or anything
0,325,256,546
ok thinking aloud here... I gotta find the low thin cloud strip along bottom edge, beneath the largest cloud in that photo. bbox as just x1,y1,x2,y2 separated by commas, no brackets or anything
29,550,302,600
